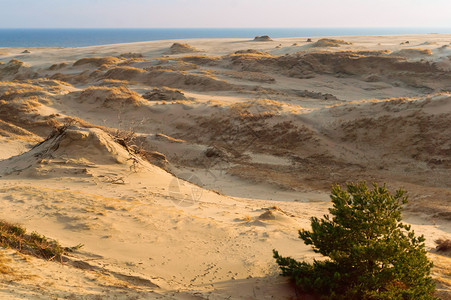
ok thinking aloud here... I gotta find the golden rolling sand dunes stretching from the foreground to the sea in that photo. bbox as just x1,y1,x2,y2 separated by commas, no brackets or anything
0,34,451,299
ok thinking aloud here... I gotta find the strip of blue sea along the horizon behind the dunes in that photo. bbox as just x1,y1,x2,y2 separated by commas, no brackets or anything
0,28,451,47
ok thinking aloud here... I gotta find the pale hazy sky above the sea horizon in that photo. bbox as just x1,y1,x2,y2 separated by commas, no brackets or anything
0,0,451,28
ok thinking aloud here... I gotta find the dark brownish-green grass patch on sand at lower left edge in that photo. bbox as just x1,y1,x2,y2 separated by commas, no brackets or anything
0,221,82,262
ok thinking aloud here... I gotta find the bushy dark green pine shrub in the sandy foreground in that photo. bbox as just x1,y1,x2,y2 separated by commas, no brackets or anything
274,182,435,299
